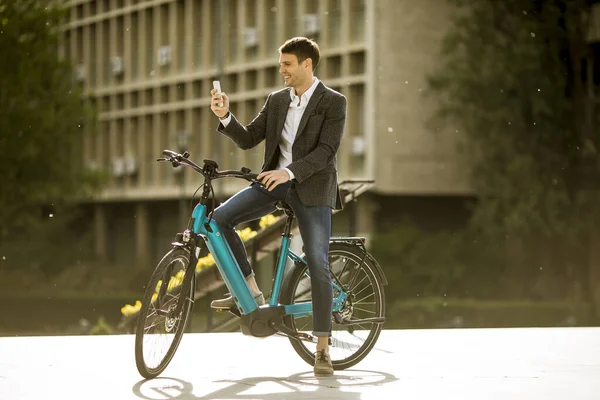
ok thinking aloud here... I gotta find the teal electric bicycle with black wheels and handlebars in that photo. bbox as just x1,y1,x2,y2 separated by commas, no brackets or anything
135,150,387,379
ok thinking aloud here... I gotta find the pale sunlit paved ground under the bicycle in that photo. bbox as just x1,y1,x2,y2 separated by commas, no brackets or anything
0,328,600,400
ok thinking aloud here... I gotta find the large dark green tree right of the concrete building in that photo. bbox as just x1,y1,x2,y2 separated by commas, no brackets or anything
429,0,600,308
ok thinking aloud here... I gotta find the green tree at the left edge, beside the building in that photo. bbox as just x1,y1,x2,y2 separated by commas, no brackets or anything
0,0,96,246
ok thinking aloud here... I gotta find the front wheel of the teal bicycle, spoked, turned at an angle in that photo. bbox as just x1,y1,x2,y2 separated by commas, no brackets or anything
135,248,195,379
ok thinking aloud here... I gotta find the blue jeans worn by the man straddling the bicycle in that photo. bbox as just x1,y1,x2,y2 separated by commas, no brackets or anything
213,181,333,336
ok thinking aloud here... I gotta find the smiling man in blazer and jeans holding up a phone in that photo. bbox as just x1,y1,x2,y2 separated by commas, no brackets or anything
211,37,346,375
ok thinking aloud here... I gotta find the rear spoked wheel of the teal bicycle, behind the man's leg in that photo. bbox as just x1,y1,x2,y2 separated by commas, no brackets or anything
283,244,385,370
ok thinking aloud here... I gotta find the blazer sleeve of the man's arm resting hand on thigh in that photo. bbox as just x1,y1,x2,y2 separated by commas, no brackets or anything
288,95,346,182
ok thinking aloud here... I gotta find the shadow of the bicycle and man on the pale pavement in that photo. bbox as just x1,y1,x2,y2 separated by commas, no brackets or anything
132,370,398,400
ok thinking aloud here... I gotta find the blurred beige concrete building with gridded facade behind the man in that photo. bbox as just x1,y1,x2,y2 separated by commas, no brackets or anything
61,0,469,264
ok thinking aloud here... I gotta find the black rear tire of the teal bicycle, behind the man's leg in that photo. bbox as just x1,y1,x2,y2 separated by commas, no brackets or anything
282,243,385,370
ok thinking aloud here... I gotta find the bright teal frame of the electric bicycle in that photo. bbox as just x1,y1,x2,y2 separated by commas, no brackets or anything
191,203,347,317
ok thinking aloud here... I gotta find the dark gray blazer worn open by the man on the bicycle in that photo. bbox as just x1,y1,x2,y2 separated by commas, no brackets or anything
217,82,346,209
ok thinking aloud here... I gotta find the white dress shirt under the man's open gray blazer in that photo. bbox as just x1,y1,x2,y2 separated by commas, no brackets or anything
221,77,319,179
